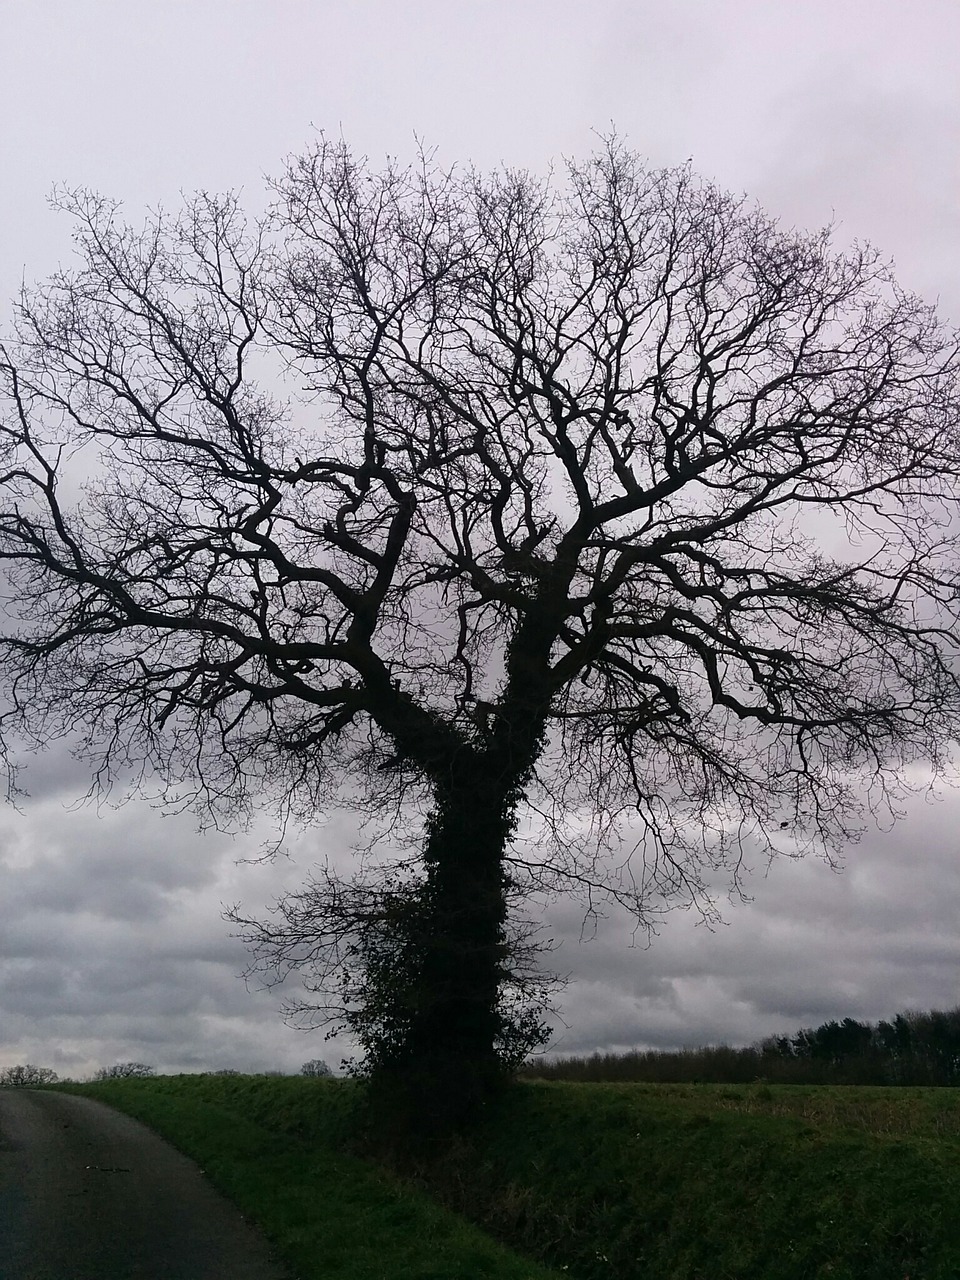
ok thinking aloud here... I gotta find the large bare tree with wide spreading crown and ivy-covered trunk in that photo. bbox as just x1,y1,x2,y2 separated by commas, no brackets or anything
0,141,960,1121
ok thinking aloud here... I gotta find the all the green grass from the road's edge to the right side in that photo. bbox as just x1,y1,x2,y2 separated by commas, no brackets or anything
54,1076,960,1280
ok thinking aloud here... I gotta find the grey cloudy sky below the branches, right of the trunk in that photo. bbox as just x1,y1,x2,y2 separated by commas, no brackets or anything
549,792,960,1052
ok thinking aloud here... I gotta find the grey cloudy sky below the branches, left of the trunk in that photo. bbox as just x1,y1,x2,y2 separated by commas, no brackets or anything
0,747,368,1074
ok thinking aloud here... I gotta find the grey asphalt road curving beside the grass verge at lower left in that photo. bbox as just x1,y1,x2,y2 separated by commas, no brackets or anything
0,1089,288,1280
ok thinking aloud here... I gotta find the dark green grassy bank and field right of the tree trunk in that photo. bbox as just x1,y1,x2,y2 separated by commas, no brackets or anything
461,1084,960,1280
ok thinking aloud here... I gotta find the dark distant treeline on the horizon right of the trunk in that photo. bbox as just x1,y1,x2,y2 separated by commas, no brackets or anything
522,1007,960,1084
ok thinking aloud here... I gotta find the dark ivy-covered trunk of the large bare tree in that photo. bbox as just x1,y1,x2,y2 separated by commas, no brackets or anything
372,589,566,1134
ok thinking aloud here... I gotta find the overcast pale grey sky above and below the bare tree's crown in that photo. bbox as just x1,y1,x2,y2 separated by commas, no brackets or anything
0,0,960,1076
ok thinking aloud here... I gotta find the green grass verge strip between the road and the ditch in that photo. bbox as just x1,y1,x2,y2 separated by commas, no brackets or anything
56,1076,561,1280
